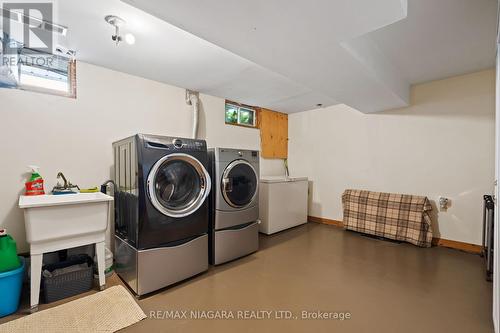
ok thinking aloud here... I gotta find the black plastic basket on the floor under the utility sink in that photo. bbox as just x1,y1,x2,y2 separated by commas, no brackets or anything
42,255,94,303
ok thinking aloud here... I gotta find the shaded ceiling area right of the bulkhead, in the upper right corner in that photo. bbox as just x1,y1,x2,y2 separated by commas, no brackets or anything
369,0,498,84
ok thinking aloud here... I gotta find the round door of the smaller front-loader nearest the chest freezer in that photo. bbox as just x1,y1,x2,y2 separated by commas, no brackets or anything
221,160,259,208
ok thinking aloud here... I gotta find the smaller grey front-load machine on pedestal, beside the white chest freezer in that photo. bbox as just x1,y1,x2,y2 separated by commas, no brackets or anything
208,148,259,265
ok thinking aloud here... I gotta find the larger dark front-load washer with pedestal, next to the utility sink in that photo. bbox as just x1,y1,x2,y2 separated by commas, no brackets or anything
113,134,211,295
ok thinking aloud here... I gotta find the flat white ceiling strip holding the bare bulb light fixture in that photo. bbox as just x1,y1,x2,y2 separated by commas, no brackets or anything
44,0,335,112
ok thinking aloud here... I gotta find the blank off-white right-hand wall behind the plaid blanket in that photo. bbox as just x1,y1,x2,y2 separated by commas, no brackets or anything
289,70,495,244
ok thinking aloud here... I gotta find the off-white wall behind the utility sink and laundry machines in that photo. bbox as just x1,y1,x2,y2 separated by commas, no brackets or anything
0,63,284,252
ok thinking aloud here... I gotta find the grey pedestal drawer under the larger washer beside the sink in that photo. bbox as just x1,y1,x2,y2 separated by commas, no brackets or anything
115,235,208,296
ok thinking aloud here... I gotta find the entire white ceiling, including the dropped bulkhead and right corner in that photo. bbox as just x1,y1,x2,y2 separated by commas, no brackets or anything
9,0,497,113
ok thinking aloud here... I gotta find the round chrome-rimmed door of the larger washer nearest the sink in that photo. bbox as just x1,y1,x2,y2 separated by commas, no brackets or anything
147,153,211,217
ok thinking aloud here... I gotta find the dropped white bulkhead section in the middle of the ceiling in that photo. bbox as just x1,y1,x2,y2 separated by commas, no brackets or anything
120,0,408,111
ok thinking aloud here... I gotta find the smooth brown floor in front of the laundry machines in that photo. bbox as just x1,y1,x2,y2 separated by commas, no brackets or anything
0,223,493,333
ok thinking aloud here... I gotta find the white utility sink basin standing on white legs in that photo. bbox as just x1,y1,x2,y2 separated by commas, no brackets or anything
19,192,113,310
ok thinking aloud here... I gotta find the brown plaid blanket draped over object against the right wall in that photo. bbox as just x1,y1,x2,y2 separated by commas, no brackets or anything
342,190,432,247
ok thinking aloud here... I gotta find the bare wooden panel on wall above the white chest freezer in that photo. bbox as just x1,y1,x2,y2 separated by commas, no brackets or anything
258,109,288,159
